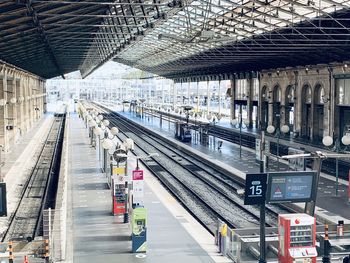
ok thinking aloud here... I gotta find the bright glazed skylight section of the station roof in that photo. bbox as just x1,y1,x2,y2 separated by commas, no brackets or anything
111,0,350,72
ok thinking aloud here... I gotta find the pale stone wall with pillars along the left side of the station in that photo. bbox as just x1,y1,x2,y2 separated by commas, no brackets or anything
0,60,46,151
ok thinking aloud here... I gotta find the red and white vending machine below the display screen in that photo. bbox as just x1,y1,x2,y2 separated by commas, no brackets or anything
278,214,317,263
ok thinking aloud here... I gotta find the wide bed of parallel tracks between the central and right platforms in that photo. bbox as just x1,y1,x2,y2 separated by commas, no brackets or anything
93,103,292,233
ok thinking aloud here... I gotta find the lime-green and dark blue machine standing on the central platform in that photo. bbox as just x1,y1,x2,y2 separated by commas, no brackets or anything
131,207,147,253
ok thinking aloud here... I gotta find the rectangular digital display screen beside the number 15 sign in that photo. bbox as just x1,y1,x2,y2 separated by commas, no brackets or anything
266,171,317,203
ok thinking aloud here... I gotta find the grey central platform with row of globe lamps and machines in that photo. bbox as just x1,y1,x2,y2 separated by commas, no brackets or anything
68,113,230,263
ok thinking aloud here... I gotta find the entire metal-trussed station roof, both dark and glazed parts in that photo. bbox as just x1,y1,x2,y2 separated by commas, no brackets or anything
0,0,350,78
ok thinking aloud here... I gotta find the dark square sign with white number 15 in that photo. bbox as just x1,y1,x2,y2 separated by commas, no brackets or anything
244,173,267,205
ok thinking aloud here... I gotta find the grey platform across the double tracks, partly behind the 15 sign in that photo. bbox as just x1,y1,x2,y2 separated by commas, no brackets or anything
114,108,350,224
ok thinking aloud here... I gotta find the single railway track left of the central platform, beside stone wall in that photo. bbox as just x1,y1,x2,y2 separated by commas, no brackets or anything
2,114,65,242
